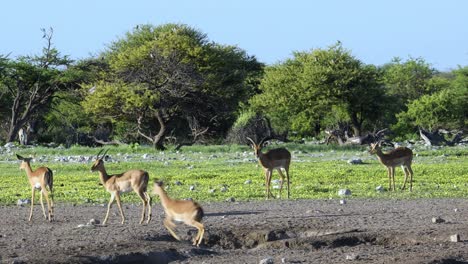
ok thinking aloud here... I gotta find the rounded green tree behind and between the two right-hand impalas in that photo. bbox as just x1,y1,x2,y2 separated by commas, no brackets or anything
251,42,385,135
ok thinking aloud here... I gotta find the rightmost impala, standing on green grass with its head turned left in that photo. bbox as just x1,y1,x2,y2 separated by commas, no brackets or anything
369,143,413,191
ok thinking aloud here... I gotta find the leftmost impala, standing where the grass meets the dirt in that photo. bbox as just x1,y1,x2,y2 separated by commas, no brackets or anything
16,154,54,221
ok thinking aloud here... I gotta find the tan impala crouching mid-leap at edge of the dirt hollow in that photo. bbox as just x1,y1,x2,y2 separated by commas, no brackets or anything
154,182,205,247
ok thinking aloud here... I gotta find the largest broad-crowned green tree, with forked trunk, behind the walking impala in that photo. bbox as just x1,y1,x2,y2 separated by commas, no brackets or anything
84,24,262,149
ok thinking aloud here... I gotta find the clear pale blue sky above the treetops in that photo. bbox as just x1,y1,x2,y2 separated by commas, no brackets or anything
0,0,468,71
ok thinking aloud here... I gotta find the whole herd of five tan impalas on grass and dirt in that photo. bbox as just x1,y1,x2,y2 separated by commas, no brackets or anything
16,138,413,246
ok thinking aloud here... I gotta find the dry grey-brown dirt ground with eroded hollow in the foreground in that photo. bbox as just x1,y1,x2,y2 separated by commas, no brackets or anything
0,199,468,264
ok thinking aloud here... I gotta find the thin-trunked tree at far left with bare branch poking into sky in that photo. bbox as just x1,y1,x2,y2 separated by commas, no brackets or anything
0,29,71,142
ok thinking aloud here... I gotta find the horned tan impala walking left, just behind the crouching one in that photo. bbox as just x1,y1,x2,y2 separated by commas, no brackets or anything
91,149,151,225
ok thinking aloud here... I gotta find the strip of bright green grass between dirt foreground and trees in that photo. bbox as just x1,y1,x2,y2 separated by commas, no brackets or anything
0,144,468,205
